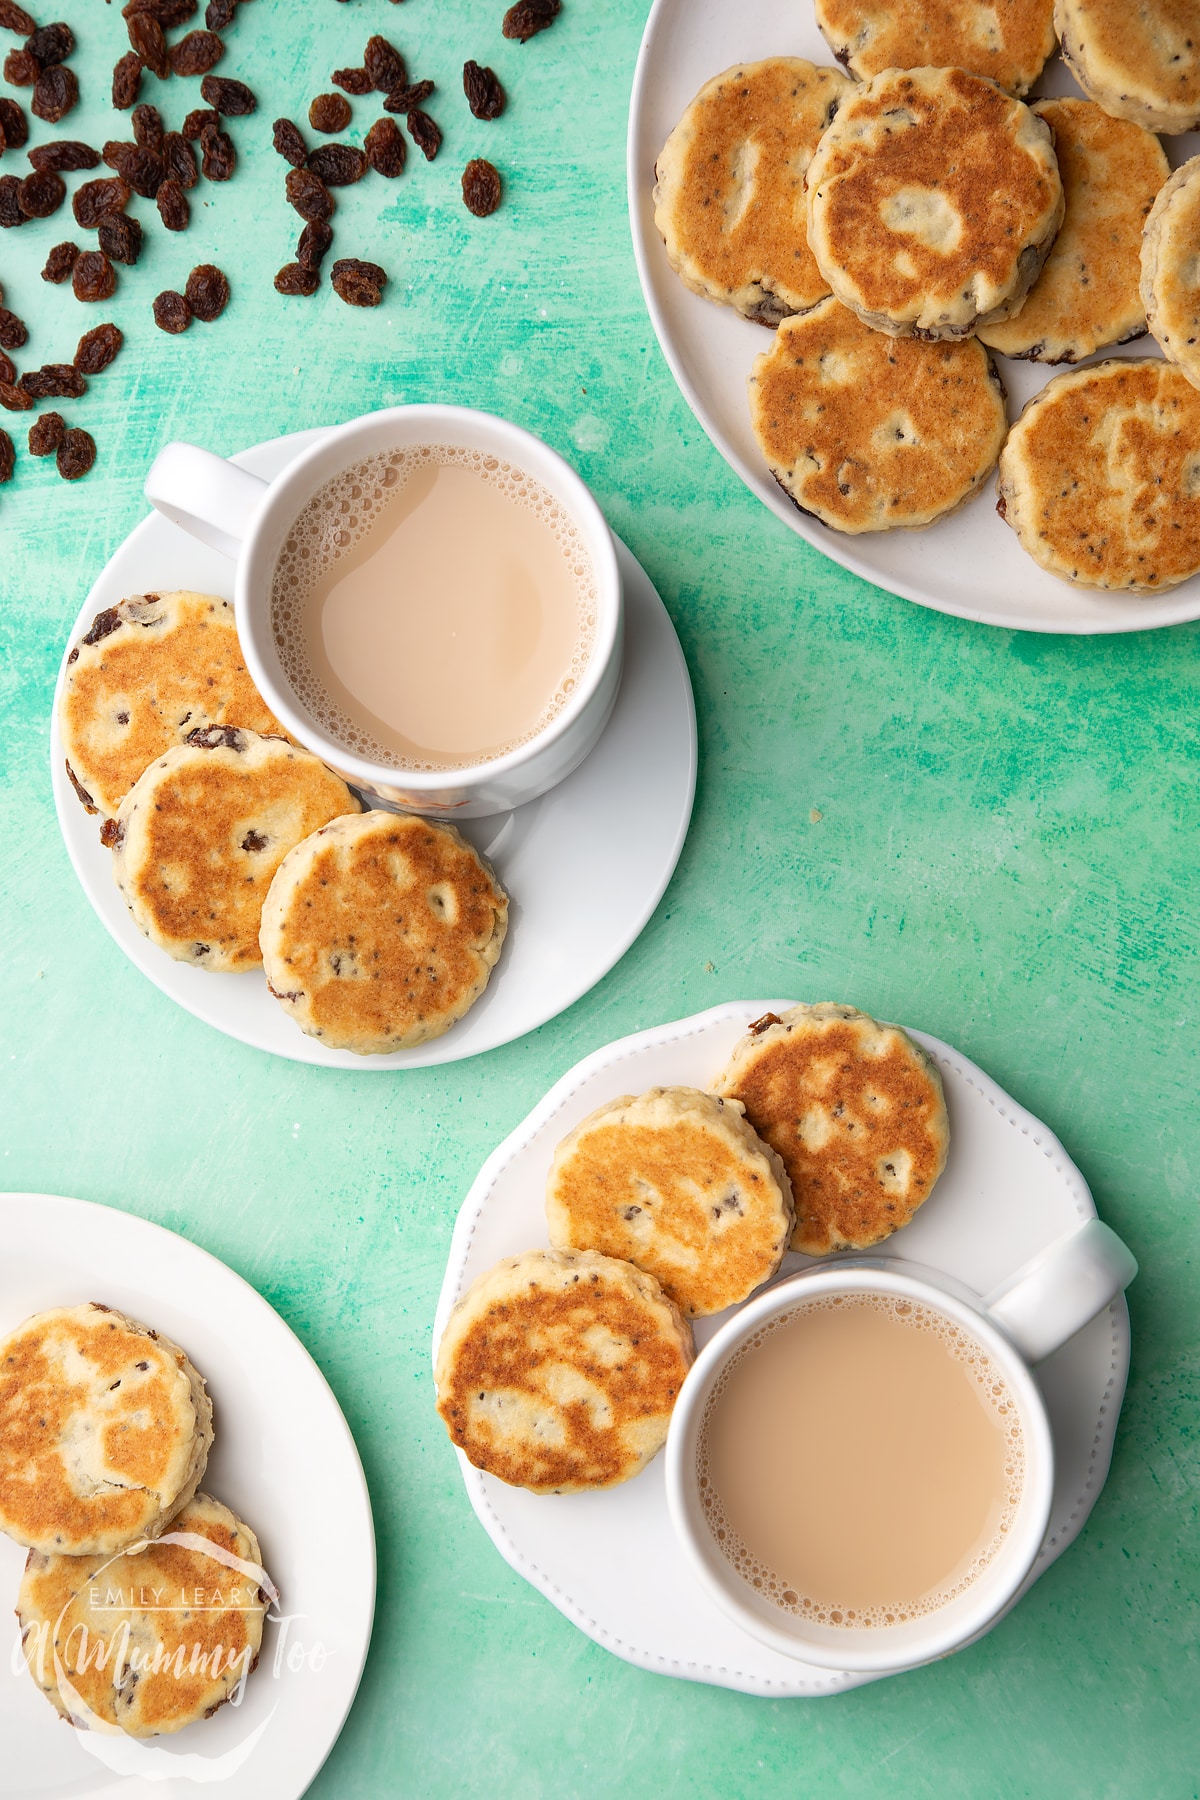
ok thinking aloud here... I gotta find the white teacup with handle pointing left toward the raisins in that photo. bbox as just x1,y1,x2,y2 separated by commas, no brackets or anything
146,405,624,819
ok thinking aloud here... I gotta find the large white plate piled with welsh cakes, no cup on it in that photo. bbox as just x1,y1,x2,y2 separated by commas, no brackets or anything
628,0,1200,632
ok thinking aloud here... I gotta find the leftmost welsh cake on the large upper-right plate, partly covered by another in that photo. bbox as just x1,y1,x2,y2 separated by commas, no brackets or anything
655,56,853,326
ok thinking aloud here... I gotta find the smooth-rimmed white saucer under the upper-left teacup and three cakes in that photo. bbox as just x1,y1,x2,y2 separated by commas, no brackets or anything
50,432,696,1073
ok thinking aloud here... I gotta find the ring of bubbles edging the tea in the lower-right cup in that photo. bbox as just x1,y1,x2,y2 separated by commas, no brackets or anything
696,1294,1025,1631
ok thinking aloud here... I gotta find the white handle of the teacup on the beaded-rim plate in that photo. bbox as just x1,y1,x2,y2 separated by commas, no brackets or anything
984,1219,1137,1363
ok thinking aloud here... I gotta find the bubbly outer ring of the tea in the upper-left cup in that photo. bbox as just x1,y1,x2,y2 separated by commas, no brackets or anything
272,445,599,772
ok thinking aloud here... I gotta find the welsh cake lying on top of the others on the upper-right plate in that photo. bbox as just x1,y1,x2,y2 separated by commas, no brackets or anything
806,68,1063,338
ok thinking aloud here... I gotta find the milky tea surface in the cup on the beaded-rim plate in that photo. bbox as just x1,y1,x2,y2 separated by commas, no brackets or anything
698,1294,1025,1629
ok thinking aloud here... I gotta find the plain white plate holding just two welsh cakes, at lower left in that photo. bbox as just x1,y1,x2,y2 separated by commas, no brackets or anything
0,1193,374,1800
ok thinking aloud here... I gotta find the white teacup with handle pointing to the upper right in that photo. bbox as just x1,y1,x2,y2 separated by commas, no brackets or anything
666,1219,1137,1672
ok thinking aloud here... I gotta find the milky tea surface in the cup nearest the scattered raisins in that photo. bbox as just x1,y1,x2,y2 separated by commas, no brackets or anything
272,445,596,769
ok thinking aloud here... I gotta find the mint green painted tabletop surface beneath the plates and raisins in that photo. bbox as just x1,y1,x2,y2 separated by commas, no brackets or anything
0,0,1200,1800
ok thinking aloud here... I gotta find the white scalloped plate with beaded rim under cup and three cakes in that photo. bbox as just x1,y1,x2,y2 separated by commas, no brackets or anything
434,1001,1130,1697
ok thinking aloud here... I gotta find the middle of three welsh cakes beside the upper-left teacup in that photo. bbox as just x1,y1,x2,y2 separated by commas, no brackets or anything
104,725,358,972
